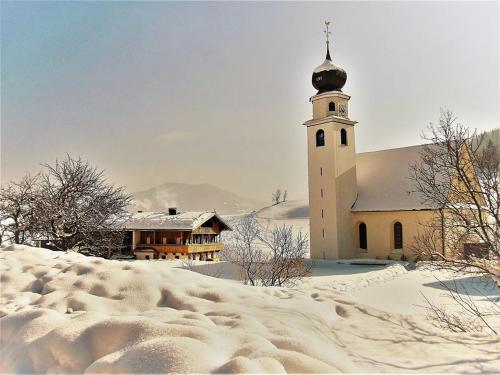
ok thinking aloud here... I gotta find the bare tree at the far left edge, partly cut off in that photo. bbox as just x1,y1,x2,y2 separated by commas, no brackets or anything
0,175,40,244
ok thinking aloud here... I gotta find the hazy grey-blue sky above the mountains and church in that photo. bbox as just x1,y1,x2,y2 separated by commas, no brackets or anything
1,1,500,200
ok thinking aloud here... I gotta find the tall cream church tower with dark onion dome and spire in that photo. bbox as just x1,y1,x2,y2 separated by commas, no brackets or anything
304,22,357,259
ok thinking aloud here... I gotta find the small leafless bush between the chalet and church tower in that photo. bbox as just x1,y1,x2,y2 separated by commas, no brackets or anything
224,213,314,286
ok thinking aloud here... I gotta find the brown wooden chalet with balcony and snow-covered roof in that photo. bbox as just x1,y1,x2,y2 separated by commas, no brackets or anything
123,209,231,260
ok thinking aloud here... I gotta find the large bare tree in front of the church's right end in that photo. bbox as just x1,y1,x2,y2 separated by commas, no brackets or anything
411,110,500,329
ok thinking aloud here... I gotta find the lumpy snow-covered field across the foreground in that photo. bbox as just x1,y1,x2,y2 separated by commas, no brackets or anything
0,246,500,373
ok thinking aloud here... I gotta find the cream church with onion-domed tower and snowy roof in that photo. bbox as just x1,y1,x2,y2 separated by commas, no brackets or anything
304,30,446,259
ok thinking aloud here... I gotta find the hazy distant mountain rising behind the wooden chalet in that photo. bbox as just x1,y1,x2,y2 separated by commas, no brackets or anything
130,182,266,215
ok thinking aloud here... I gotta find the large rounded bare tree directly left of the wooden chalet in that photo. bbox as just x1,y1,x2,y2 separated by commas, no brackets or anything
34,155,130,257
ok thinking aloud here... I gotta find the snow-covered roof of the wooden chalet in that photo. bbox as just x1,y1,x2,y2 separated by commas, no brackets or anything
123,211,229,230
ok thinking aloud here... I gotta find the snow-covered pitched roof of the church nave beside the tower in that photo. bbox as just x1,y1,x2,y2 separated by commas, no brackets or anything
352,145,433,212
